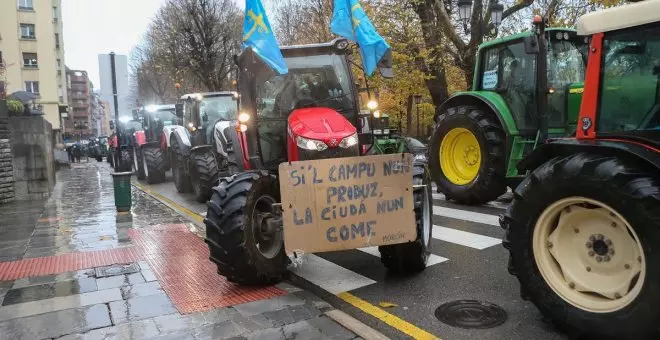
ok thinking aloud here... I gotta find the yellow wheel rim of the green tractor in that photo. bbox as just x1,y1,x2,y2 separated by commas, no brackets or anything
440,128,481,185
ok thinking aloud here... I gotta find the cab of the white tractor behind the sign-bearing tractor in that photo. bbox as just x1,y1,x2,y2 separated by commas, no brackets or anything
176,91,237,146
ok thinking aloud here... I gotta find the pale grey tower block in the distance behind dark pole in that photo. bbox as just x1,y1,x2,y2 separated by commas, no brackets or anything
99,54,130,117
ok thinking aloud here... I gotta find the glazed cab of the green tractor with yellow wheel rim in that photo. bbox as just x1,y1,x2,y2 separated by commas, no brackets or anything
473,28,588,136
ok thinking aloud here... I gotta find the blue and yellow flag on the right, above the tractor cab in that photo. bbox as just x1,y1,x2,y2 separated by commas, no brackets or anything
330,0,390,76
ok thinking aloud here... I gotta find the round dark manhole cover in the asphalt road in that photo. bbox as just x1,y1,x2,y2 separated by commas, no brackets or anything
435,300,507,329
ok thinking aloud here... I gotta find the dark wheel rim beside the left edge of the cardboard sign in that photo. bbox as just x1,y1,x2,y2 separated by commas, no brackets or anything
252,195,284,259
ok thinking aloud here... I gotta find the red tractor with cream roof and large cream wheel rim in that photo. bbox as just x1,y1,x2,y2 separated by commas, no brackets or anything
500,0,660,339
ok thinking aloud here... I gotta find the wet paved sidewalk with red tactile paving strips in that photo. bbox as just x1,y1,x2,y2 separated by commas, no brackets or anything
0,160,368,340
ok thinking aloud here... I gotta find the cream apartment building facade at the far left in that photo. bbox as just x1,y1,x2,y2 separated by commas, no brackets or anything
0,0,68,136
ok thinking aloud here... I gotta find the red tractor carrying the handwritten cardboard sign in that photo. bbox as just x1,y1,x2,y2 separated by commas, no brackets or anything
205,39,431,284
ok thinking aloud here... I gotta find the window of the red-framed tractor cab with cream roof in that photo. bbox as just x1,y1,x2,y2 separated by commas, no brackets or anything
596,24,660,136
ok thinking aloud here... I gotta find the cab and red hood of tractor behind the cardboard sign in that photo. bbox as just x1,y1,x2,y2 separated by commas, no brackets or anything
236,39,361,169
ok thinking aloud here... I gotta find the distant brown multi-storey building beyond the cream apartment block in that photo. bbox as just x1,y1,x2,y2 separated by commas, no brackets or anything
64,68,93,140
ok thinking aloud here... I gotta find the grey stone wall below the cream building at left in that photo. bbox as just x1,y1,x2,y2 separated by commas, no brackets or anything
8,116,55,201
